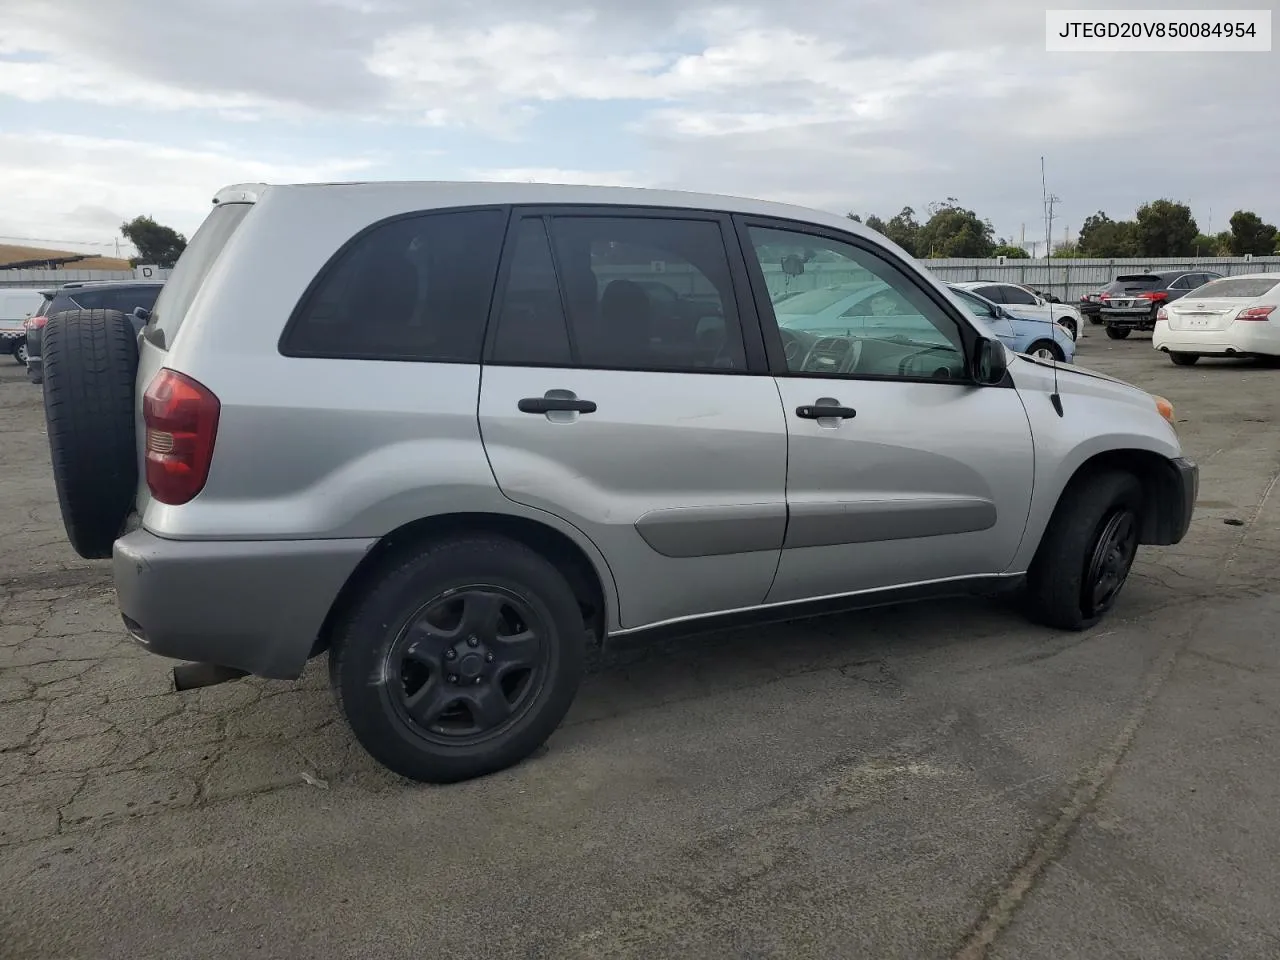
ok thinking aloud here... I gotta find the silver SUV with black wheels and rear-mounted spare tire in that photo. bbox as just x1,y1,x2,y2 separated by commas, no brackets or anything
45,183,1198,782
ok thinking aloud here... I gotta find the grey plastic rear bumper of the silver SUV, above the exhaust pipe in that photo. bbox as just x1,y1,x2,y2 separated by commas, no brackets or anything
111,530,375,680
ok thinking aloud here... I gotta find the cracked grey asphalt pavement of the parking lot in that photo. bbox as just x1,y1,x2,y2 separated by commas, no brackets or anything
0,335,1280,960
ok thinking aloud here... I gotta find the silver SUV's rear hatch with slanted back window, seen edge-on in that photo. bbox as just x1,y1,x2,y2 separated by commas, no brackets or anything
134,200,253,516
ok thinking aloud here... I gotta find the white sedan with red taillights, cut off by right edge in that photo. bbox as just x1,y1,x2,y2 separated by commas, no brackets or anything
1151,274,1280,366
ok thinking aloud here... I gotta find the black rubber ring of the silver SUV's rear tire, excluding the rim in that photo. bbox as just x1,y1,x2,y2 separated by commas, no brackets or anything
329,534,586,783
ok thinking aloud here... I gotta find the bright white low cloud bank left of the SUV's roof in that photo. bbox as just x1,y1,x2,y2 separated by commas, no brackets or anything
0,132,374,243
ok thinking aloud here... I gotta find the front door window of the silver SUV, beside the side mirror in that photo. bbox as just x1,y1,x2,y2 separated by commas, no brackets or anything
749,227,966,379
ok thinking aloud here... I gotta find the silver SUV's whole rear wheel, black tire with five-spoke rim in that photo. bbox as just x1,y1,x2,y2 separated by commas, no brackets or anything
329,535,588,783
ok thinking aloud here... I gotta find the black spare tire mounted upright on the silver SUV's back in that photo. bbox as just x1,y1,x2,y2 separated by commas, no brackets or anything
41,310,138,559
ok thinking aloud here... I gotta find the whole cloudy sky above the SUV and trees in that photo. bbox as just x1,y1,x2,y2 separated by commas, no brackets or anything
0,0,1280,256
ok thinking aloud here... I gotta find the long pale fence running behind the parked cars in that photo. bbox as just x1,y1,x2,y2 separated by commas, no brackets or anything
0,257,1280,301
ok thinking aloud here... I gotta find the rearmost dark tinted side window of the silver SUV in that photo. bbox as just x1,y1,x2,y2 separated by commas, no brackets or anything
288,210,507,364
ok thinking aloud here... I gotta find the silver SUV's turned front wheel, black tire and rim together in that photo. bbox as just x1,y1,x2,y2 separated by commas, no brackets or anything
1025,470,1142,630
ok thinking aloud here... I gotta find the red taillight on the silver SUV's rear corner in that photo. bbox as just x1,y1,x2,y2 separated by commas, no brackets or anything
142,369,221,504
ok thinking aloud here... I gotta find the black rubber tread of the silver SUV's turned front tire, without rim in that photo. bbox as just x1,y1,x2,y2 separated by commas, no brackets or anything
1024,470,1142,630
